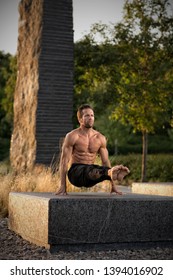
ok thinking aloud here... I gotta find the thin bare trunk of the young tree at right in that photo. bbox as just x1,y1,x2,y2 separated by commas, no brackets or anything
141,131,148,182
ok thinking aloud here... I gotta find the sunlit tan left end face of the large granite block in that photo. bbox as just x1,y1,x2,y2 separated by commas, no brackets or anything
9,193,49,248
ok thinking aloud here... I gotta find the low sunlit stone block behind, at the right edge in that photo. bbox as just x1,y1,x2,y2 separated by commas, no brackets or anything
132,182,173,197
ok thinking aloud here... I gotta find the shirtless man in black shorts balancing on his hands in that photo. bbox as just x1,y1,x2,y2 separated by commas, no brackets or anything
55,104,130,195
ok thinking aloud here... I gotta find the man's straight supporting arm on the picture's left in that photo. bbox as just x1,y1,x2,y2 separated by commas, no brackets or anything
55,134,73,195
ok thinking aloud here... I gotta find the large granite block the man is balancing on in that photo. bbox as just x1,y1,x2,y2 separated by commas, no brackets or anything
9,192,173,252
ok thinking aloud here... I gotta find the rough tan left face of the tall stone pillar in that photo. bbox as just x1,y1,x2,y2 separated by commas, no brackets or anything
10,0,43,170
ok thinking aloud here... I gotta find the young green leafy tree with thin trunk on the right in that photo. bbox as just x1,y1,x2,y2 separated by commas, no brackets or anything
110,0,173,181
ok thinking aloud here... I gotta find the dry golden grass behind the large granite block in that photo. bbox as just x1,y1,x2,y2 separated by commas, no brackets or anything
0,162,110,217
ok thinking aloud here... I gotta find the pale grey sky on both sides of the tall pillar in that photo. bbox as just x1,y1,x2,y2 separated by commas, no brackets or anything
0,0,125,55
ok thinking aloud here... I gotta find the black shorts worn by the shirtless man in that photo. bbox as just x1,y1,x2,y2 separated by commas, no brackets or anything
67,163,111,188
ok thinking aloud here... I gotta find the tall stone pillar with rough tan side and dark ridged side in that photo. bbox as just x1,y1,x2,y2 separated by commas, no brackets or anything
10,0,73,171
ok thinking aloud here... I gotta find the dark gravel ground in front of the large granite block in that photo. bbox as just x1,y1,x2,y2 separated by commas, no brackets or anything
0,218,173,260
